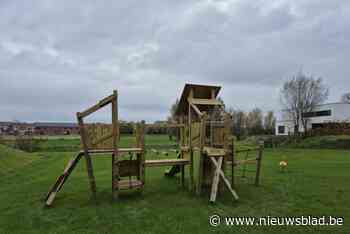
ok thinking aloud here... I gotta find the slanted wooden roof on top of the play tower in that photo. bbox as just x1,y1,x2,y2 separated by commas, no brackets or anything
176,84,222,115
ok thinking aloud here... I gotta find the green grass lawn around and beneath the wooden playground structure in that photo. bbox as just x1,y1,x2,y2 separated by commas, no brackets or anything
0,136,350,233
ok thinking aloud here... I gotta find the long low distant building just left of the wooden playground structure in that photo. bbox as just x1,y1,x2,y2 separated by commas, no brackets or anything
33,122,79,135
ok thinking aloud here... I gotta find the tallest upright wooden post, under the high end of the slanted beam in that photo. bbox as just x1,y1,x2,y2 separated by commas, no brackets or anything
112,90,119,199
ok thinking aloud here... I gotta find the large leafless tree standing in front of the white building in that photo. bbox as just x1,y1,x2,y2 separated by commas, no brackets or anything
281,72,329,135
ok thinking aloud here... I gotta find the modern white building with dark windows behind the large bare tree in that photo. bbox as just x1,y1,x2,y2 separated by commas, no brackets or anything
276,102,350,135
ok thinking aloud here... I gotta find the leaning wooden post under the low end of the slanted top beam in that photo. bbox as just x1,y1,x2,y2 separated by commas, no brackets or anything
77,112,96,199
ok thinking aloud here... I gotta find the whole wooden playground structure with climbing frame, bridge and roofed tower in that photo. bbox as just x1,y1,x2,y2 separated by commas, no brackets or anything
45,84,263,206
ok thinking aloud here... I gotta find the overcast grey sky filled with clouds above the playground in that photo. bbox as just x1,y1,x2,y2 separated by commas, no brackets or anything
0,0,350,121
